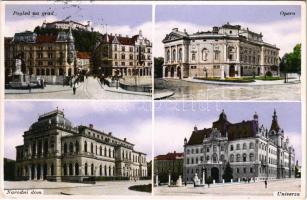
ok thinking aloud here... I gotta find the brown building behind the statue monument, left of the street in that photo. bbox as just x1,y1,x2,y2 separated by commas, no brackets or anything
5,30,76,82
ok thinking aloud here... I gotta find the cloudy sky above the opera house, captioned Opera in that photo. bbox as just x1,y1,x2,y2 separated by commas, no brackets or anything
154,5,301,57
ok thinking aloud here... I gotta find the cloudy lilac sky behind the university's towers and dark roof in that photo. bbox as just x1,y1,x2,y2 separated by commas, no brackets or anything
154,102,302,163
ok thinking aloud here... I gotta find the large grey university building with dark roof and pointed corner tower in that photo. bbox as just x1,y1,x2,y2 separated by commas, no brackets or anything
183,110,295,182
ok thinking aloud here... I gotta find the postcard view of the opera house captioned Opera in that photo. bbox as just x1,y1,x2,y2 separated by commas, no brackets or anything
154,4,305,101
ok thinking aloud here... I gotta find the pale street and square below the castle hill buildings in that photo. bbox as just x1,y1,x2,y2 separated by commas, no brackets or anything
5,77,151,100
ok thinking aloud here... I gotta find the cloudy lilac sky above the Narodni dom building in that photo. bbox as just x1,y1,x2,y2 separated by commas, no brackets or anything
4,101,152,160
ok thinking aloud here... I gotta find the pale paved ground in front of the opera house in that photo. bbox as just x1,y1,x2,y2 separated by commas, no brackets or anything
155,79,301,101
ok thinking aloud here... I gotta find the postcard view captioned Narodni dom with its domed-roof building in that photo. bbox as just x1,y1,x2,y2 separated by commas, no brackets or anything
4,101,152,197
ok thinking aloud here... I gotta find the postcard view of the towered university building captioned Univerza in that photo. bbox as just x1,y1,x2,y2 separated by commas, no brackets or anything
153,101,302,197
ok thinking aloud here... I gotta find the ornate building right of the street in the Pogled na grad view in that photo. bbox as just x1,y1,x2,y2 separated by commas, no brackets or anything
93,31,152,76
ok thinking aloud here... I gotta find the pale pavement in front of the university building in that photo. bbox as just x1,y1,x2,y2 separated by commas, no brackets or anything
153,179,301,199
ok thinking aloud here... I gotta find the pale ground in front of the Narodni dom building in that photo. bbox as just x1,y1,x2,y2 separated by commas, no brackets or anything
4,180,151,196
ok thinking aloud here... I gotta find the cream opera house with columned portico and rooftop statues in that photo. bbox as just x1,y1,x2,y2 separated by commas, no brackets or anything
162,23,279,79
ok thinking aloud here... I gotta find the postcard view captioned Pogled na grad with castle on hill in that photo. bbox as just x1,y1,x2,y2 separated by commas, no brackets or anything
3,1,152,100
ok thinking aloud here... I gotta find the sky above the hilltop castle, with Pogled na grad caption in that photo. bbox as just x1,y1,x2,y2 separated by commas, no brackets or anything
4,3,152,39
